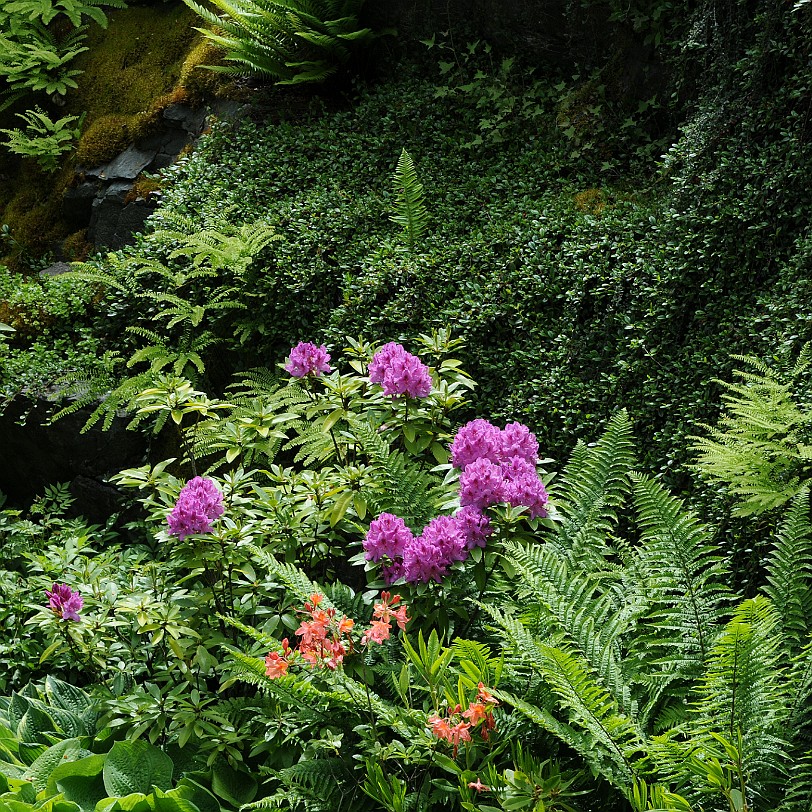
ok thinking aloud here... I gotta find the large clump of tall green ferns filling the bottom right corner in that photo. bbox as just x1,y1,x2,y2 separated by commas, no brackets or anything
484,413,812,812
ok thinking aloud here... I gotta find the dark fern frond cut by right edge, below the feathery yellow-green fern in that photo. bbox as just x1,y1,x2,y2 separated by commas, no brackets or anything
763,487,812,654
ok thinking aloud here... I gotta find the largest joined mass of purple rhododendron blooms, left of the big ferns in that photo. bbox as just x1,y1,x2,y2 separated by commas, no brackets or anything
364,420,547,584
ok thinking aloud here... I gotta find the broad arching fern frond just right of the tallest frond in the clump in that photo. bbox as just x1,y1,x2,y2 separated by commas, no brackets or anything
631,474,729,679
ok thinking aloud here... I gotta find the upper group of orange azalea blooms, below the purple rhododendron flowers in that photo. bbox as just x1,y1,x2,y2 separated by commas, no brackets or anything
265,592,409,679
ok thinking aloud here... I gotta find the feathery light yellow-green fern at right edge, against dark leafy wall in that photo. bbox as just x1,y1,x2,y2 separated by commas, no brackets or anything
691,344,812,516
